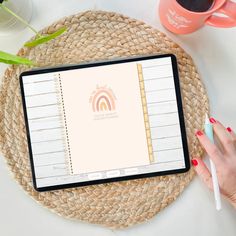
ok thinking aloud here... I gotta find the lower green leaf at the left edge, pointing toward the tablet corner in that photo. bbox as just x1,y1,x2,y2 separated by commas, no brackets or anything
0,51,34,65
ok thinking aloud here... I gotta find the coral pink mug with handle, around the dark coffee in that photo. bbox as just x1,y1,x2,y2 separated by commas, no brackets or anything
159,0,236,34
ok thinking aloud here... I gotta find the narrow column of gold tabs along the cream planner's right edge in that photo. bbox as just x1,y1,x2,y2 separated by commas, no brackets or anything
137,64,154,163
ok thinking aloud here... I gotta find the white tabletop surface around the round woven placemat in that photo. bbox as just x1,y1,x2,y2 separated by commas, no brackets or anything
0,0,236,236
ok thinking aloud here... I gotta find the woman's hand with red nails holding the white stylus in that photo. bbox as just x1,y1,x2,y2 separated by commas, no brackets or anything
192,118,236,208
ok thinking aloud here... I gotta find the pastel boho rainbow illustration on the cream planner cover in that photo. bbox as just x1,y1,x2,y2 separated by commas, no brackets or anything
90,87,116,112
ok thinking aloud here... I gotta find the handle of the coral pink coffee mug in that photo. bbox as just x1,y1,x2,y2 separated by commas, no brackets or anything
206,1,236,28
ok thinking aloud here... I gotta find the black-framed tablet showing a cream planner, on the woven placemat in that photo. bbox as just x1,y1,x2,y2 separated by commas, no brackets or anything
20,54,190,191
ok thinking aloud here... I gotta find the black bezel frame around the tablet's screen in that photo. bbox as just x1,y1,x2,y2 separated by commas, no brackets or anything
20,54,190,192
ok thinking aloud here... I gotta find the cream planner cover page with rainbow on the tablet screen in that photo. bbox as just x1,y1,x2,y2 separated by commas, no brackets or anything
61,63,150,174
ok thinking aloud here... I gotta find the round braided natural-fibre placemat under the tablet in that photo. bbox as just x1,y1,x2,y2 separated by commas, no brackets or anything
0,11,209,228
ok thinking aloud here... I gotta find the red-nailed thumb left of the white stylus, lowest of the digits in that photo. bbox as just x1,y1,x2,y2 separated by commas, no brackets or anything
192,158,213,190
